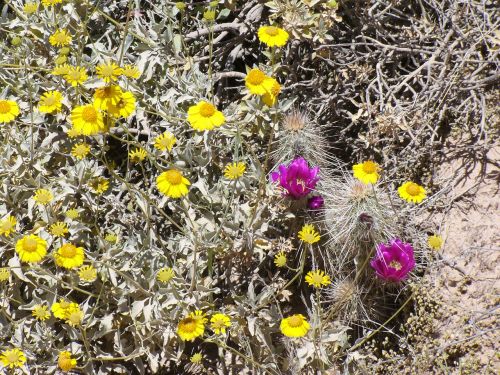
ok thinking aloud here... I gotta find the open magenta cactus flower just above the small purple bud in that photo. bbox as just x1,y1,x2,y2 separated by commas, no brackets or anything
271,157,319,199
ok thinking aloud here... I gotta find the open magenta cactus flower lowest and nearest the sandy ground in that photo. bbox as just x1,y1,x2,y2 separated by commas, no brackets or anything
370,239,415,282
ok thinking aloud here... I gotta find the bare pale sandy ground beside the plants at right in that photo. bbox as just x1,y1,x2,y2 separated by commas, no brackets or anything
428,148,500,374
